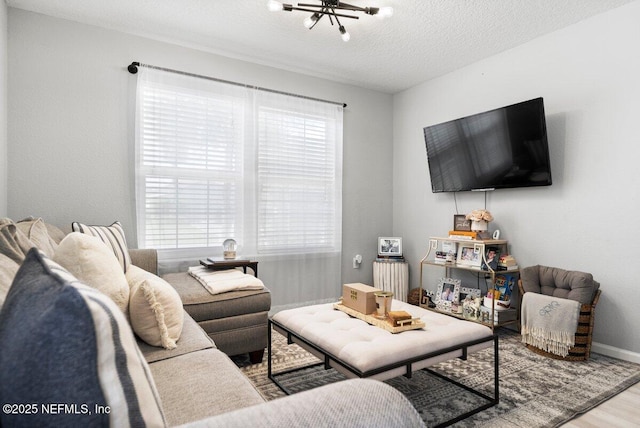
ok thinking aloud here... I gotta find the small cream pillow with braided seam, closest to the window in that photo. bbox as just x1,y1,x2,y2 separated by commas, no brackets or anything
125,265,184,349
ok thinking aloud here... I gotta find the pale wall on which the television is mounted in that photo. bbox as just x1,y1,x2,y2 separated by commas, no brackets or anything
393,2,640,356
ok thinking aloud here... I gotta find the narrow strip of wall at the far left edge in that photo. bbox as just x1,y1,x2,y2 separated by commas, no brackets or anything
0,1,8,217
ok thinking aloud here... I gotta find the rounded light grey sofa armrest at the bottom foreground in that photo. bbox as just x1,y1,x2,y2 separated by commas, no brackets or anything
178,379,425,428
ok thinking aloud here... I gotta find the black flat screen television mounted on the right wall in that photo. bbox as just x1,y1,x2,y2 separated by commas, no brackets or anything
424,98,551,193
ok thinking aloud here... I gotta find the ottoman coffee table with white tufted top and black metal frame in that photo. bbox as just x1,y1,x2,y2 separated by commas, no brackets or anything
267,300,499,426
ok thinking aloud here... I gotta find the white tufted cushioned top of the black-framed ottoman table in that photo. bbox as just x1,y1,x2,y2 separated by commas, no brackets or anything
273,300,493,380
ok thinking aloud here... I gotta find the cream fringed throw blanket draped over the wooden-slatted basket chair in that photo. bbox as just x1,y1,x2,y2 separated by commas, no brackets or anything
521,293,581,357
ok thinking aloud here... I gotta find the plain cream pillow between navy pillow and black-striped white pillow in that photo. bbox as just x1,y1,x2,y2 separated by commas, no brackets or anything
53,232,129,314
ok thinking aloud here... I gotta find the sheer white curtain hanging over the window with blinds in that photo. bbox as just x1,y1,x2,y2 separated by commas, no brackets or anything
135,67,342,305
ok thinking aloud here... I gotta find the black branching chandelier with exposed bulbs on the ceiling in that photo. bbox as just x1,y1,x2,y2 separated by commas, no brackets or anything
267,0,393,42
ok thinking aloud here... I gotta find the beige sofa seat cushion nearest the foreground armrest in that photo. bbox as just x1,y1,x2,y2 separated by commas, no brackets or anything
149,349,264,425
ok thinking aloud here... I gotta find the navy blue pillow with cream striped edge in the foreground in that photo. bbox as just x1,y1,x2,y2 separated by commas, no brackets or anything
0,249,165,426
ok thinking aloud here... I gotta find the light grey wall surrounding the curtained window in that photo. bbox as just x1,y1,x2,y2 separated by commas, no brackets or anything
8,8,392,304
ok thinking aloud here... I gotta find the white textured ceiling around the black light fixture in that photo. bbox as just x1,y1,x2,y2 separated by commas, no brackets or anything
6,0,640,93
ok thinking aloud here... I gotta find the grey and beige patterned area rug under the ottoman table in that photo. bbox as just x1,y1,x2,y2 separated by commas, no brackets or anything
234,329,640,428
